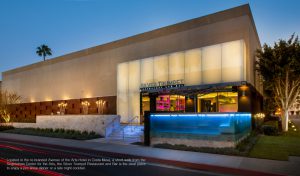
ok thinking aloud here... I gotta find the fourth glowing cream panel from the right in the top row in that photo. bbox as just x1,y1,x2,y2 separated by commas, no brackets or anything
169,52,184,81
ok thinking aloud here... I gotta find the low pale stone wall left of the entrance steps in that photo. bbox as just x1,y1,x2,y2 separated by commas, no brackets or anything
12,115,120,137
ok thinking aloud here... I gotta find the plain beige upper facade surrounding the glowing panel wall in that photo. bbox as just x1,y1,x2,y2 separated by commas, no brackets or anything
2,5,261,103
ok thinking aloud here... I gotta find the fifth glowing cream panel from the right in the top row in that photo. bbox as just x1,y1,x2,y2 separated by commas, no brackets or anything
154,55,169,82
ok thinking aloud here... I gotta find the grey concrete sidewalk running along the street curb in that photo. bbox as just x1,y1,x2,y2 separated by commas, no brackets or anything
0,133,300,175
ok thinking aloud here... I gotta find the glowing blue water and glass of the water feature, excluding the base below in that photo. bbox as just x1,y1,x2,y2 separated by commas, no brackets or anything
150,113,251,141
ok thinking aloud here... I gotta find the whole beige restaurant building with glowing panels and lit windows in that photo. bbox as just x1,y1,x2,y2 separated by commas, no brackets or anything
2,5,262,123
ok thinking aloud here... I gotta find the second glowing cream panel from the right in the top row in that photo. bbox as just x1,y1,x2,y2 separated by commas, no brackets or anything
202,45,221,84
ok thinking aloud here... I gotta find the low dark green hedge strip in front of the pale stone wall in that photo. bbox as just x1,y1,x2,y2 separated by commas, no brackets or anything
0,127,103,140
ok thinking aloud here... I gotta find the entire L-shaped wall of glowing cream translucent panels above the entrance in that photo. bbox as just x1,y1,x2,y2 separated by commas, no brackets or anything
117,40,246,122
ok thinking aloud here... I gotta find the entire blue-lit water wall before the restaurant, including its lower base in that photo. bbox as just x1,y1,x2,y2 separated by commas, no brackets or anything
149,112,251,148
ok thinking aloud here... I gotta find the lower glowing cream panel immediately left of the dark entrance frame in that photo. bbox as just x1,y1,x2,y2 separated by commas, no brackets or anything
128,92,140,123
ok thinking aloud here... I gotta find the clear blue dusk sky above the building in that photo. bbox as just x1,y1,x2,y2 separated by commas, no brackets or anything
0,0,300,79
